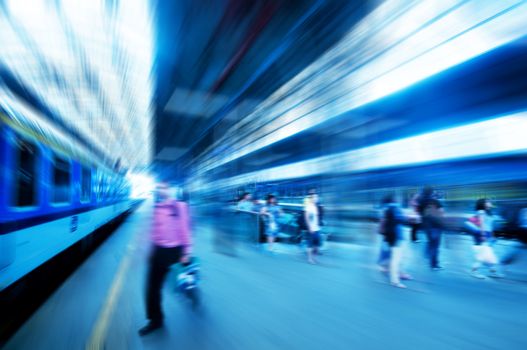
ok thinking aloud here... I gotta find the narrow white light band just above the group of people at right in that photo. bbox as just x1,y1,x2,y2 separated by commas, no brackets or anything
194,112,527,190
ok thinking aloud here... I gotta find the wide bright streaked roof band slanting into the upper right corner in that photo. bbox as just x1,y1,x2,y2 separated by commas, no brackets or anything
198,1,527,173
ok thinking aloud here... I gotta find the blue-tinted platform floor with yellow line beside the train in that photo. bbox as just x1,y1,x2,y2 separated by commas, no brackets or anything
5,203,527,350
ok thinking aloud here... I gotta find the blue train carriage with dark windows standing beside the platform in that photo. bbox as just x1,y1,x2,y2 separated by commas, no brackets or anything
0,109,134,291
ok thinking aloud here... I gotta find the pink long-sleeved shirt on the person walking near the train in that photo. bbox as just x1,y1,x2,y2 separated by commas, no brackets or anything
150,199,192,254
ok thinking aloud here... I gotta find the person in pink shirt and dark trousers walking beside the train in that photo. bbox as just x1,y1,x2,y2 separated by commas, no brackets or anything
139,183,191,335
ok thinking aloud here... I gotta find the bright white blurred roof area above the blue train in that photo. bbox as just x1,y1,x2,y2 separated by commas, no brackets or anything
0,0,154,170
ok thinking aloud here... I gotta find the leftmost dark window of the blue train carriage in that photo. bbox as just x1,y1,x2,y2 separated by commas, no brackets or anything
12,139,37,207
